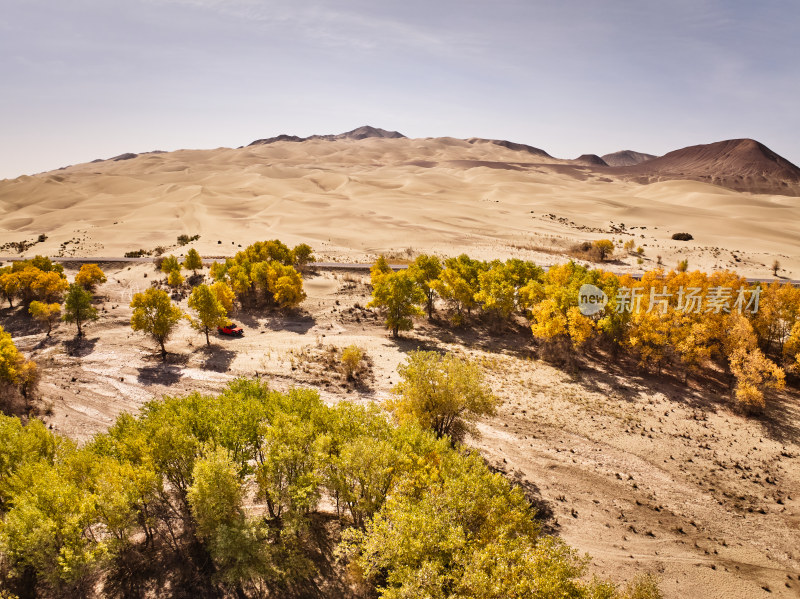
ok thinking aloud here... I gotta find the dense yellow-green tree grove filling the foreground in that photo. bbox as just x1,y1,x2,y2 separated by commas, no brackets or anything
0,379,659,599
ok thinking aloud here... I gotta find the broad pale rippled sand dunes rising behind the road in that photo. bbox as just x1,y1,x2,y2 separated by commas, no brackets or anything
0,138,800,277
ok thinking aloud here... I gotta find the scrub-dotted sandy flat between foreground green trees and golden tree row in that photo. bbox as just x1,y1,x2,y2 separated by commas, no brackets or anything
0,264,800,599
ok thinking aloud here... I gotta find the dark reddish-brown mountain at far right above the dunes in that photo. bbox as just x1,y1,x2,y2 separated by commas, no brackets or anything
603,139,800,196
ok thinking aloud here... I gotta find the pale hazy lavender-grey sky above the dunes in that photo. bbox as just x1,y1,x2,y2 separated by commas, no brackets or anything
0,0,800,178
